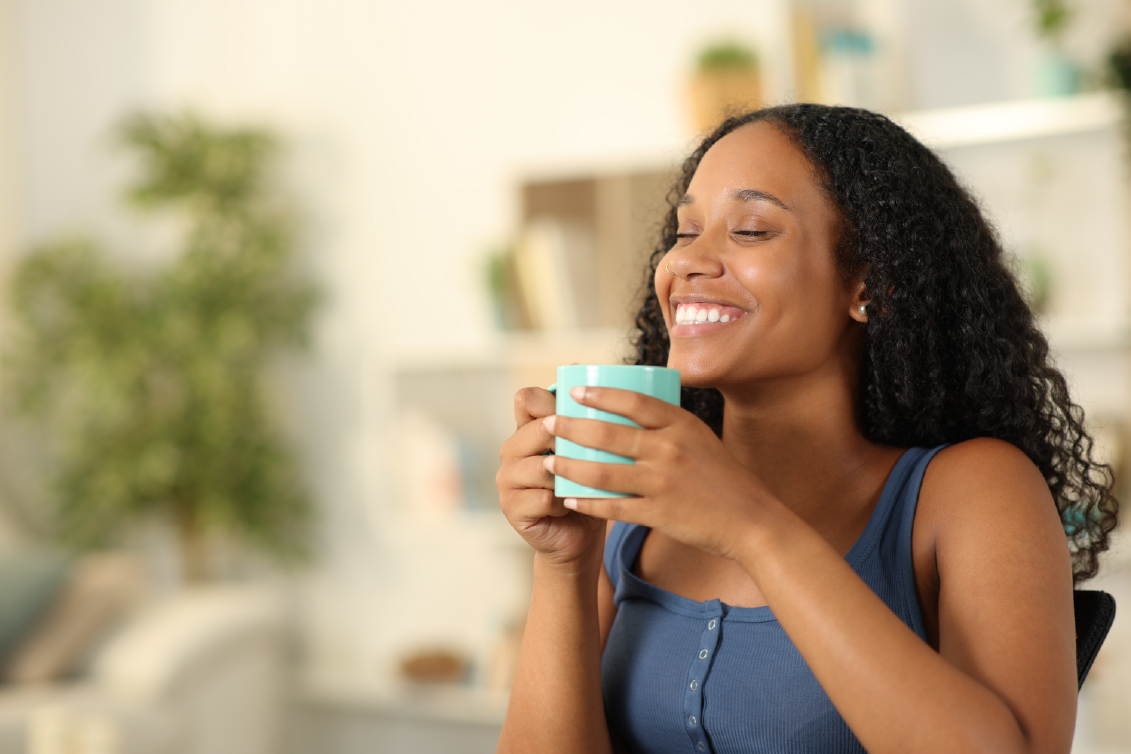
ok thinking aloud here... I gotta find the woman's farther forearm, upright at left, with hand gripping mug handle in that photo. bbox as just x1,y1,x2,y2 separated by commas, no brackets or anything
495,389,615,754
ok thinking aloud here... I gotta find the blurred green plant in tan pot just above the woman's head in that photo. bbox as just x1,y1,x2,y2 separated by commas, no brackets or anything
689,42,762,133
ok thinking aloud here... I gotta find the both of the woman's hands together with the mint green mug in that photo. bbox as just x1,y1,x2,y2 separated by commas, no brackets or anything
497,366,761,561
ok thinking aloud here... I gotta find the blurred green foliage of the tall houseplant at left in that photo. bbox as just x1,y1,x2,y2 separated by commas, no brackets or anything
7,115,317,578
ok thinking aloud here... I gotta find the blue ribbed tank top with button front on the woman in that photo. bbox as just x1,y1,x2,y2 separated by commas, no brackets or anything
601,447,941,754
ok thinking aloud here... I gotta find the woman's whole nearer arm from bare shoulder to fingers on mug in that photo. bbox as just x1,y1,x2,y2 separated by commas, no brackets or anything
552,389,1076,753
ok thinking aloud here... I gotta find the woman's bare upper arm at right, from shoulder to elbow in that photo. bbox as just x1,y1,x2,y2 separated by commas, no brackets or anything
913,439,1077,740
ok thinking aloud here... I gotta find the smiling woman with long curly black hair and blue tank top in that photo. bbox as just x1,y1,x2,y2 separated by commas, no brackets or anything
498,105,1115,754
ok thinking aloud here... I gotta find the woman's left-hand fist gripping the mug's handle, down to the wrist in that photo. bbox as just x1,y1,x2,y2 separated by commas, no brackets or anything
495,388,605,565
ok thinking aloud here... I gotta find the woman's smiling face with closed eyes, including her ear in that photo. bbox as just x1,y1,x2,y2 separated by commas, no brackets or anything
656,122,865,389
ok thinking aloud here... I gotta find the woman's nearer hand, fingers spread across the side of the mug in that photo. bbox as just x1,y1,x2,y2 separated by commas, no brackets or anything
541,388,769,558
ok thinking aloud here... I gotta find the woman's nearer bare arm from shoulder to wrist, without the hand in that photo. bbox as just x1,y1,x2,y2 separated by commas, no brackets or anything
736,440,1077,753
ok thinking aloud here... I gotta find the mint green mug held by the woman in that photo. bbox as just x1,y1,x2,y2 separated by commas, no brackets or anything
550,364,680,497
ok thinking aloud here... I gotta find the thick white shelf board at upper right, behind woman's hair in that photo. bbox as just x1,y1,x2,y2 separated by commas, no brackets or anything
893,92,1123,149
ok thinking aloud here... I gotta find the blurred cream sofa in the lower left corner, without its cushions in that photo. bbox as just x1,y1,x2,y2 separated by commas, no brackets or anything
0,586,286,754
